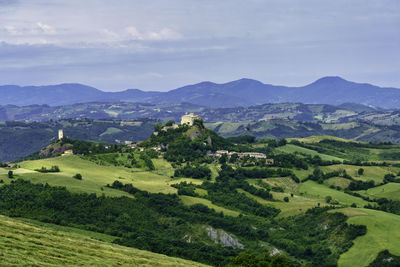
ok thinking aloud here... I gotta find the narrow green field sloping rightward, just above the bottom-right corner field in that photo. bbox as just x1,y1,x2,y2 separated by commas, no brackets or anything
298,181,368,207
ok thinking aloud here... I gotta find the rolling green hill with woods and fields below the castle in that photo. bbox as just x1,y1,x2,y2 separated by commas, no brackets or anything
0,127,400,266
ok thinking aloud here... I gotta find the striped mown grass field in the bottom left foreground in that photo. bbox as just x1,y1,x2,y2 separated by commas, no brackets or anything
0,216,205,266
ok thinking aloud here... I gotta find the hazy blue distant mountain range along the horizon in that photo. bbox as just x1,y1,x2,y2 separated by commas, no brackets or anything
0,77,400,109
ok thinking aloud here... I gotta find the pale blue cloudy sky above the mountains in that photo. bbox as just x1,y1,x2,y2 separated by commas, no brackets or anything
0,0,400,91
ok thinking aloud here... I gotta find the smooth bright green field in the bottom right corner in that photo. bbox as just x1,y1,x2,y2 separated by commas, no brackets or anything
333,208,400,267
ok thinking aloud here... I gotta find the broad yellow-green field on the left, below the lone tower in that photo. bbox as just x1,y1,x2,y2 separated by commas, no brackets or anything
15,156,176,196
